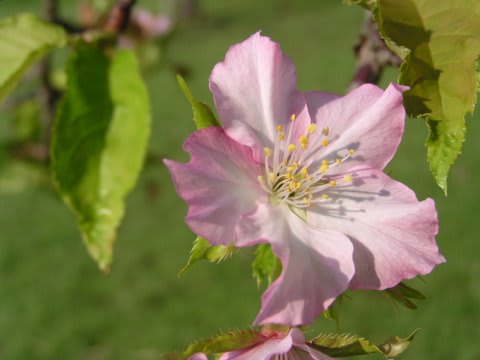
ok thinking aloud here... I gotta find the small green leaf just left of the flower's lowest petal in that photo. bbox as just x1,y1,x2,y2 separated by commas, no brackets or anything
252,244,282,286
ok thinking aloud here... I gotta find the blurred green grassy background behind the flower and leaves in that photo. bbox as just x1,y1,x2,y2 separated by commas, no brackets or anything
0,0,480,360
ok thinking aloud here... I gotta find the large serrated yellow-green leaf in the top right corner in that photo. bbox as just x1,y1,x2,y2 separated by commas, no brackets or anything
353,0,480,194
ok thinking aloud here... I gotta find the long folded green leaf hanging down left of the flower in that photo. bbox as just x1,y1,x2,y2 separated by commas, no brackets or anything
51,46,150,270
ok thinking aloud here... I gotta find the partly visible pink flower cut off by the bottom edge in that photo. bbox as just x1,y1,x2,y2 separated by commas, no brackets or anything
220,329,331,360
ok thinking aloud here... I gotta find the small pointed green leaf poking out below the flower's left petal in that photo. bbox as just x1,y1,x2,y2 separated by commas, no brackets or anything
178,236,237,276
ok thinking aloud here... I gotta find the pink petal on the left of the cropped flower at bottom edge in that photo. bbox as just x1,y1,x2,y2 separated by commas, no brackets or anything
220,333,292,360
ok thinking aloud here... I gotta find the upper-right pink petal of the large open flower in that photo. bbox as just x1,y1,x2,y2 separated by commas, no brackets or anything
305,84,406,169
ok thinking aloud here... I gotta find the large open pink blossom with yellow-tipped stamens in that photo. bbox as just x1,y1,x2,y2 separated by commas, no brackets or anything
165,33,444,326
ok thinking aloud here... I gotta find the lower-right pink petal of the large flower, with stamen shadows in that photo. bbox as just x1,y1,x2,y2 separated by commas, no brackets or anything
307,167,445,289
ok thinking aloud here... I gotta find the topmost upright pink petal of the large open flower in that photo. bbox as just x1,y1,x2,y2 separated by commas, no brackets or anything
210,32,310,159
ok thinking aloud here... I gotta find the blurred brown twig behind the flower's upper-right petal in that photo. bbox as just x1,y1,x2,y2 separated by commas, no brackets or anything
350,14,402,90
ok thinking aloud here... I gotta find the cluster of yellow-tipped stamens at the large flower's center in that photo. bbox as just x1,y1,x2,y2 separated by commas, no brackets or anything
258,114,354,208
